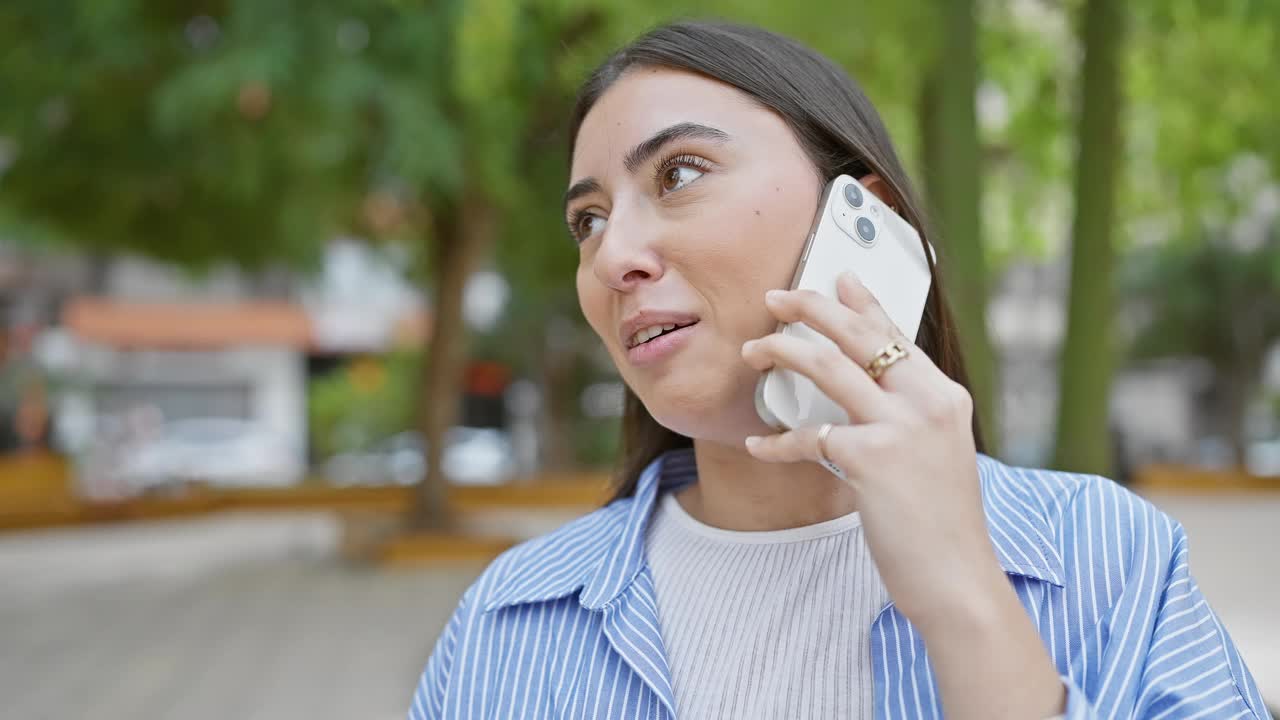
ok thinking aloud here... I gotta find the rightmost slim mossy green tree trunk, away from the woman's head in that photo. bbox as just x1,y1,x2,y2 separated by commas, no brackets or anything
1053,0,1125,475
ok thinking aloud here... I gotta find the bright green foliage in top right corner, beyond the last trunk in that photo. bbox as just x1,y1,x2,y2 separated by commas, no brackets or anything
1124,0,1280,224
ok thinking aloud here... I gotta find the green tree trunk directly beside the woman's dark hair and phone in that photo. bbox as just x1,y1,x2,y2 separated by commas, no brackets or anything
919,0,1000,454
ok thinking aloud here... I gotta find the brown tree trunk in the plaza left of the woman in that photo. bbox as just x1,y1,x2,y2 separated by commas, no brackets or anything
408,192,497,530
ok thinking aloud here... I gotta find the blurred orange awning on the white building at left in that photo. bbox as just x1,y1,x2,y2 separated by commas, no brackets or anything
61,297,429,352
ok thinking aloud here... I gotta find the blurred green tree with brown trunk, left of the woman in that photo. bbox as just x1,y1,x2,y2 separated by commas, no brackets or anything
0,0,596,527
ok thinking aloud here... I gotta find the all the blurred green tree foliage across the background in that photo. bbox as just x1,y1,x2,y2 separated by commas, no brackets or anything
0,0,1280,484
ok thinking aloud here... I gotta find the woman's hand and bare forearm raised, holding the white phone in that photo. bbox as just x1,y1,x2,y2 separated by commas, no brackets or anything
742,273,1065,719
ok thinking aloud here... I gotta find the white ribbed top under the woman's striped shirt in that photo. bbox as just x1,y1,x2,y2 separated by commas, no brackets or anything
645,492,888,720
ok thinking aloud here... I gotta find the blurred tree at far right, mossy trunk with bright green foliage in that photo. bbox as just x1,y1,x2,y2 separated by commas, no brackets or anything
1053,0,1280,473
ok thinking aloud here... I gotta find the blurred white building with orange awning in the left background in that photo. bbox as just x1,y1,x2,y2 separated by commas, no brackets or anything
8,241,428,495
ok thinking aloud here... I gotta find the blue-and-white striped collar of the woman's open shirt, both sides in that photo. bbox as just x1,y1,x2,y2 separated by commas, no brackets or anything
485,448,1062,612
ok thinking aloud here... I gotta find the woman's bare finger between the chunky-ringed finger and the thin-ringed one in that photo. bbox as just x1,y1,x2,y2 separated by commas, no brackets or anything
742,333,891,423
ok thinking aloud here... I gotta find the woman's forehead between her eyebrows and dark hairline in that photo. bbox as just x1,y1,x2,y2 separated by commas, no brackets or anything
571,68,790,181
